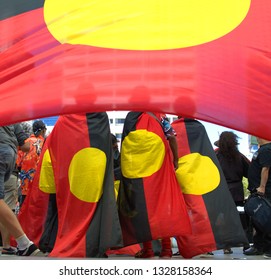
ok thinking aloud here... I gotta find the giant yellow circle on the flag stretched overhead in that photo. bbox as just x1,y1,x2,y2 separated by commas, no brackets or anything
44,0,251,50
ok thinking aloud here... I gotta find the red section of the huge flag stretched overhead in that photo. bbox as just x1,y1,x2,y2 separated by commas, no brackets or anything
0,0,271,139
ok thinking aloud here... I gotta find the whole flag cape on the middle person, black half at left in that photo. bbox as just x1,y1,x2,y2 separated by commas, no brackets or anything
118,112,191,246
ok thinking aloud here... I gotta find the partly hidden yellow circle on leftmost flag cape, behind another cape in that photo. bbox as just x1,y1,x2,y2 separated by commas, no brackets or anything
39,149,56,193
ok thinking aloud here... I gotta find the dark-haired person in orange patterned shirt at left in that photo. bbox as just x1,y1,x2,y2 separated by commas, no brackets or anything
17,120,47,207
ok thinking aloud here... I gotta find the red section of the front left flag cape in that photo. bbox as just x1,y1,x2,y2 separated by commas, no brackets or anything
46,115,97,257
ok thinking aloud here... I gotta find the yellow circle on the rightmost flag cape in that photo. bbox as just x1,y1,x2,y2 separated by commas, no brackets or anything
176,153,220,195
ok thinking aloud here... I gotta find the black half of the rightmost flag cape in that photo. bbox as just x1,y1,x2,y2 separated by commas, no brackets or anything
185,119,248,249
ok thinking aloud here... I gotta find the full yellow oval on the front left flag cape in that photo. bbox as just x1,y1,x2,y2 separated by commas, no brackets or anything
68,147,106,202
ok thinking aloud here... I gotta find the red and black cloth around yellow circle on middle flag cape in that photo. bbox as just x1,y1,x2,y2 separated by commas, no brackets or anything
118,112,191,245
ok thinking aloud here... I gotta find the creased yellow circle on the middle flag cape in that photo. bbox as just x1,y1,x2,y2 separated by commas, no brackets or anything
121,129,165,179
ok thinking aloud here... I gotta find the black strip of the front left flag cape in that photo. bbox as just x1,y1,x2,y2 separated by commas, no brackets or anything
86,112,123,257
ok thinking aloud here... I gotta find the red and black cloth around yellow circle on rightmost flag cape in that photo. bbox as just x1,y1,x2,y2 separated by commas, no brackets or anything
172,119,248,258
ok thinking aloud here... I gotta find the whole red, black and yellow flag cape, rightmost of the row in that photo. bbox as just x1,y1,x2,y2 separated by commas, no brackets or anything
172,118,248,258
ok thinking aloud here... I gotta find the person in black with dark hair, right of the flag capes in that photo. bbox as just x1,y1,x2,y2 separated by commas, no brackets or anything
215,131,250,254
